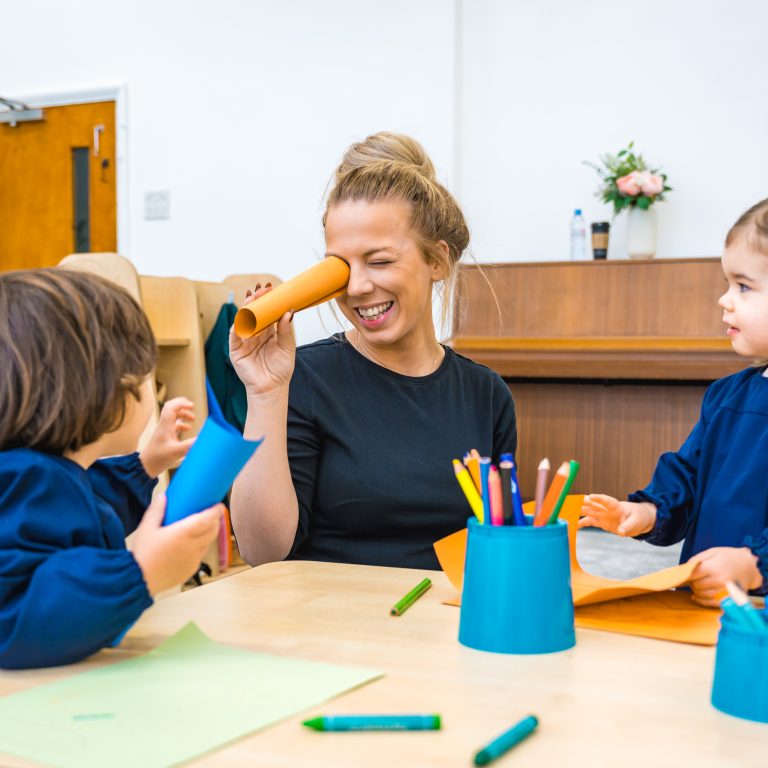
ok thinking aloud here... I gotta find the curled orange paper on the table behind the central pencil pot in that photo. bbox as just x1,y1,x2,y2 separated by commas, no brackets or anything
434,495,721,645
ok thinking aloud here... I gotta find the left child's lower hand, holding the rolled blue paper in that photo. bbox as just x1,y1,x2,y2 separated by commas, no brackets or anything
132,495,224,596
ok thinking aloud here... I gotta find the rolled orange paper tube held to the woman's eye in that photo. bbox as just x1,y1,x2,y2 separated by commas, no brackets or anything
235,256,349,339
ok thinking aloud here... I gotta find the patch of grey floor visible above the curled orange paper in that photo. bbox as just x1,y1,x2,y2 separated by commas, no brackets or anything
576,528,682,579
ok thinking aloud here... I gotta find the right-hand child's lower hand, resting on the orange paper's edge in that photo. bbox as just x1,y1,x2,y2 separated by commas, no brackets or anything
689,547,763,608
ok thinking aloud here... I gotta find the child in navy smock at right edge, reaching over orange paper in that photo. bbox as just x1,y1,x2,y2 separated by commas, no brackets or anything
579,199,768,606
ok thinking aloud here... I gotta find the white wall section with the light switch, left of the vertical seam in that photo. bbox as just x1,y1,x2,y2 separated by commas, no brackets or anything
0,0,454,341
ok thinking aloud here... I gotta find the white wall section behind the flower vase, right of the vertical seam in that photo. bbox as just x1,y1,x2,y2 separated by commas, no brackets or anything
458,0,768,261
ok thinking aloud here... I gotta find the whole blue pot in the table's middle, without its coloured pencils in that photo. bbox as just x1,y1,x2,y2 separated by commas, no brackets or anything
459,519,576,653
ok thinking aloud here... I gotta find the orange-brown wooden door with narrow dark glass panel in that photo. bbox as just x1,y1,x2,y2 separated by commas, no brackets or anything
0,101,117,271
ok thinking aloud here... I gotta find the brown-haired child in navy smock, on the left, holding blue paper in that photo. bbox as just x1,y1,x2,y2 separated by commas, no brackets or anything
0,269,222,669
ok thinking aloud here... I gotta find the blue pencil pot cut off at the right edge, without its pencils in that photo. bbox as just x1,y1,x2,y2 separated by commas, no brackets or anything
712,615,768,723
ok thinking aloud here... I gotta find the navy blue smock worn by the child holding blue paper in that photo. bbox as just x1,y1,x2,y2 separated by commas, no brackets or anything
0,448,156,669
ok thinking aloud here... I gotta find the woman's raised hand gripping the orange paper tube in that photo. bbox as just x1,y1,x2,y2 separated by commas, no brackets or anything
229,283,296,395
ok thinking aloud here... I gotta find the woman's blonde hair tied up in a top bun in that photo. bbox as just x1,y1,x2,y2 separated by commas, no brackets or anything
323,131,469,332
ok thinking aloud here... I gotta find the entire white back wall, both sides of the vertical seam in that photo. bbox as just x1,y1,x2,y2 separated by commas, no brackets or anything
0,0,768,341
